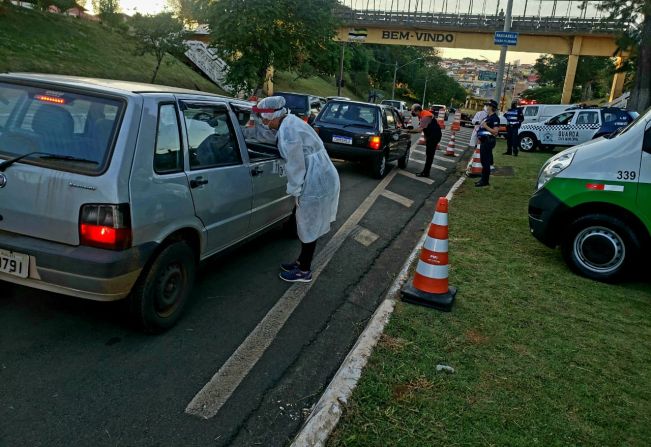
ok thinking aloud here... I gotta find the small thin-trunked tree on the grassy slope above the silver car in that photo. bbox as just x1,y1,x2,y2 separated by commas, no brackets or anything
131,12,187,83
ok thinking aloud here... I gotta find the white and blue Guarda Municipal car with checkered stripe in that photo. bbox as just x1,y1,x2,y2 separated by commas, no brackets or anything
518,107,637,152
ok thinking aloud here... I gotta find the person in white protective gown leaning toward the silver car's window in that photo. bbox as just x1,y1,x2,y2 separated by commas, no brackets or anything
253,96,339,282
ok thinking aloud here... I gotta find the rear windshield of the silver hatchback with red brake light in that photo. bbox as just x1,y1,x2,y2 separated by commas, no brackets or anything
0,82,123,174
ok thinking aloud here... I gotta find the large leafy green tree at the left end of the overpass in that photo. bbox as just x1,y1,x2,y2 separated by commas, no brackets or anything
208,0,337,93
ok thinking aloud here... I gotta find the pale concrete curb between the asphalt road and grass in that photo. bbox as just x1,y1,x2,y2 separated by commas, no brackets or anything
290,175,466,447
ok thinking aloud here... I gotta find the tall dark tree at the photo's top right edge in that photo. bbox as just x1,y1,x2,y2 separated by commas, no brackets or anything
582,0,651,112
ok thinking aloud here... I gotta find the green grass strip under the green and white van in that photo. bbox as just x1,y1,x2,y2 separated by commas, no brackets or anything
329,142,651,447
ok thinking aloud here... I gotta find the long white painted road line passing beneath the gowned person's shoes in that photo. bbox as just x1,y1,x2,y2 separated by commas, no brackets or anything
185,170,397,419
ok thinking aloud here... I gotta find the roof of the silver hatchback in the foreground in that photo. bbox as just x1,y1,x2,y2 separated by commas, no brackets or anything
0,73,251,105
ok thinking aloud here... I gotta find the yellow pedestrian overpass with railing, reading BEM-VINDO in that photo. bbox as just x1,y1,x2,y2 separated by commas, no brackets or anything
335,0,634,104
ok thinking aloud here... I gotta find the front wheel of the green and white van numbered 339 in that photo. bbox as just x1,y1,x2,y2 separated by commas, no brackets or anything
561,214,640,281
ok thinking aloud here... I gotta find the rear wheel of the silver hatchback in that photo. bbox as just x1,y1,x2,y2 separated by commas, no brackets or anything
129,241,196,333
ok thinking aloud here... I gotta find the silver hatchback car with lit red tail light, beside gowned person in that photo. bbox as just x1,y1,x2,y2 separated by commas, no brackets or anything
0,74,293,332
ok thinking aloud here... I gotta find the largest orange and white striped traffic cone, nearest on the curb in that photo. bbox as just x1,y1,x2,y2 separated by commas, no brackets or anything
401,197,457,312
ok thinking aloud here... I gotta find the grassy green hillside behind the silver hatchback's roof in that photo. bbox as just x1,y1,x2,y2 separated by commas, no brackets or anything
0,4,224,94
